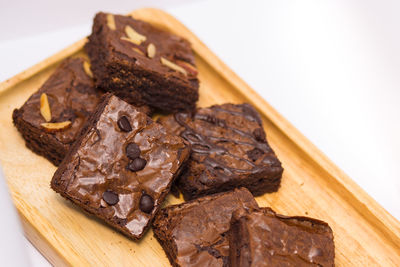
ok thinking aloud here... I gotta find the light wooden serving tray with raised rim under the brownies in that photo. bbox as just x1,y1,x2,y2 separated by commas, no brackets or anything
0,9,400,266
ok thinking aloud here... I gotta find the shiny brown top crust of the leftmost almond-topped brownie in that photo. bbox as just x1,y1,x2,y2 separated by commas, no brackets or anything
21,58,102,145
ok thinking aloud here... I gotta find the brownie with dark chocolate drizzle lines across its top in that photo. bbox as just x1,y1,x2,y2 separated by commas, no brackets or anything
159,104,283,199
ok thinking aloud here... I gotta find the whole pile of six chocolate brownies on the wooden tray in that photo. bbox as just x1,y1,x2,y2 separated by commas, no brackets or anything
13,13,335,266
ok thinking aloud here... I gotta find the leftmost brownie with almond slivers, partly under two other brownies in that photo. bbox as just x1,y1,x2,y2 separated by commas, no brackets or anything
13,58,101,165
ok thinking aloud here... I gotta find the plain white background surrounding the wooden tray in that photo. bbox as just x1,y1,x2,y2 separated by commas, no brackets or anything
0,0,400,266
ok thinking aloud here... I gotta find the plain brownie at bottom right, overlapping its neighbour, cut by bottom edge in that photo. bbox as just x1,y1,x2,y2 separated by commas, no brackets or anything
228,208,335,267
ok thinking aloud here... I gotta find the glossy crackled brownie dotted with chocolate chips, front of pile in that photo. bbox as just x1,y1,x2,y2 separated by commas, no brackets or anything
51,94,190,240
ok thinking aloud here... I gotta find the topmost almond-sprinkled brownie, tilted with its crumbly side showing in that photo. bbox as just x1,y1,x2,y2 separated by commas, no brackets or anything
85,13,199,112
